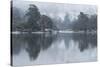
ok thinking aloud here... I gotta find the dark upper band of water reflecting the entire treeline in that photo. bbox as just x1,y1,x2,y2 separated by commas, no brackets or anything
12,33,97,65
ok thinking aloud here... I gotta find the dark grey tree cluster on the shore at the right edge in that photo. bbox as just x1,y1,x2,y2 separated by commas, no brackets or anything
72,12,97,31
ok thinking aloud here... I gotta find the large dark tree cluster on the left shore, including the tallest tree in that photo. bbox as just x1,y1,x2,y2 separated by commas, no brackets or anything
12,4,57,32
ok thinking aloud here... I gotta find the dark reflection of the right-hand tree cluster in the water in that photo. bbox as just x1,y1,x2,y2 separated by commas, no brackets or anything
72,33,97,52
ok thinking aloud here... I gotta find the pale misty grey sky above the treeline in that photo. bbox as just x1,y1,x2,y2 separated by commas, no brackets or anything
13,0,97,20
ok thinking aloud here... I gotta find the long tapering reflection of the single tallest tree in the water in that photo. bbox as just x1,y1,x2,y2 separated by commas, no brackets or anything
25,34,41,60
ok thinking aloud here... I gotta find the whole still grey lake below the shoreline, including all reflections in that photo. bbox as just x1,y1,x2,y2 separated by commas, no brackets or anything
11,33,97,66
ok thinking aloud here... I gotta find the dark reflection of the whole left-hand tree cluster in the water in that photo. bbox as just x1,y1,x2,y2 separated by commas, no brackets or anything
12,33,56,60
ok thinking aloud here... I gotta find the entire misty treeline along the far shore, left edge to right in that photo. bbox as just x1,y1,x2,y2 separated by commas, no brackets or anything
12,4,97,32
